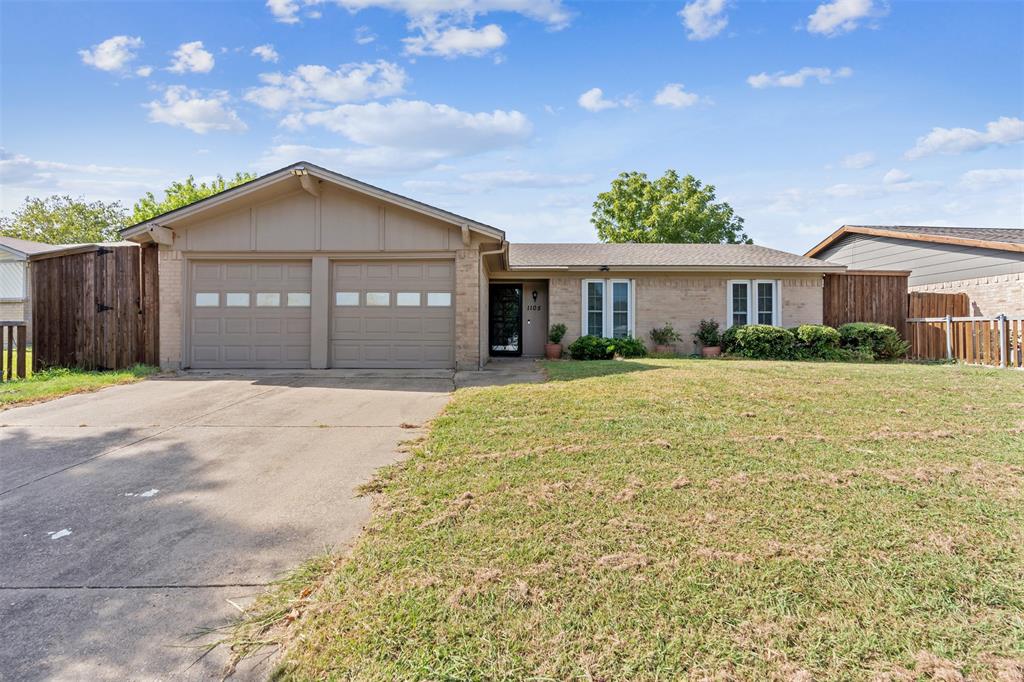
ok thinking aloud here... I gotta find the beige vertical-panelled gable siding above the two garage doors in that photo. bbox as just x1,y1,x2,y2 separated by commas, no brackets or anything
175,183,465,253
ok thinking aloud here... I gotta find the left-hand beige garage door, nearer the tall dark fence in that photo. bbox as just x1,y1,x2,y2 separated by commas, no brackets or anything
189,261,311,369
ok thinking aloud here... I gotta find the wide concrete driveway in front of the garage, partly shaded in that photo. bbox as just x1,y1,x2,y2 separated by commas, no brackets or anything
0,372,453,680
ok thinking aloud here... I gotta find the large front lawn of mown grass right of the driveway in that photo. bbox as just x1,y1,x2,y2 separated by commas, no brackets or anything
234,359,1024,680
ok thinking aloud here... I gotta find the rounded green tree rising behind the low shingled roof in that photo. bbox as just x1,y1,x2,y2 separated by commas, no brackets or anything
590,169,753,244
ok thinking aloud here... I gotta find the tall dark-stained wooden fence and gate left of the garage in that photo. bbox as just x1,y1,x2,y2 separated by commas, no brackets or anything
31,243,160,371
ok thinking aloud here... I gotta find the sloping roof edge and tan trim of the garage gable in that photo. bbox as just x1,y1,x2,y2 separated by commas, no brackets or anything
121,161,505,240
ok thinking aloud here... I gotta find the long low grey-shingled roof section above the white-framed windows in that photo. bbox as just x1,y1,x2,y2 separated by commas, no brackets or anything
508,244,846,271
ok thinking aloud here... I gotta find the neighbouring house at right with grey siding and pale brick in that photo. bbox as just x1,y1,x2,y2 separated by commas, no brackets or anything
806,225,1024,317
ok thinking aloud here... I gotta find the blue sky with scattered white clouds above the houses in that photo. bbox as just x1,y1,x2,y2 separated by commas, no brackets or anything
0,0,1024,252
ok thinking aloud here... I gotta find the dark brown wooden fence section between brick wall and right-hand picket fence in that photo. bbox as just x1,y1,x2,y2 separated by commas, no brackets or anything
821,270,909,336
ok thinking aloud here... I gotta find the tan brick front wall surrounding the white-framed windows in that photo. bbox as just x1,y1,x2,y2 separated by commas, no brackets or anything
548,272,823,353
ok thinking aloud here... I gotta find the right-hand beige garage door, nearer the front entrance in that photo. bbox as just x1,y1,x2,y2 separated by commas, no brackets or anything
331,260,455,368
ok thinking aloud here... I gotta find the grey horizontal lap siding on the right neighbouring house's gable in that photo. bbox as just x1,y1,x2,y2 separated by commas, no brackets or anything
815,235,1024,287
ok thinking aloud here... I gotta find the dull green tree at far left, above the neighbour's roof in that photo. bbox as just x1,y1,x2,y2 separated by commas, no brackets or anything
0,195,128,244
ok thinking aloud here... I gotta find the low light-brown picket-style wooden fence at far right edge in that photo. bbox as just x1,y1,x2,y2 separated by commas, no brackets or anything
907,315,1024,369
